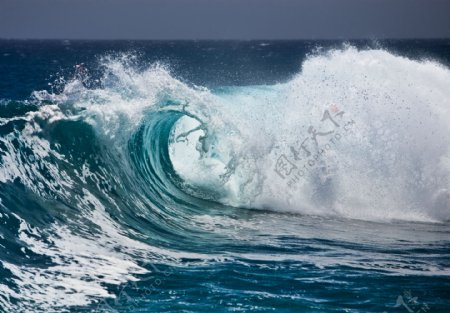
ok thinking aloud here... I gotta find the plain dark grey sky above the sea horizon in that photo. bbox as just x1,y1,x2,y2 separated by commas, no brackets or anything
0,0,450,39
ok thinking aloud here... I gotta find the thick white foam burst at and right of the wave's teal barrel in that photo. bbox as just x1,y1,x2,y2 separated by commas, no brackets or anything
172,48,450,221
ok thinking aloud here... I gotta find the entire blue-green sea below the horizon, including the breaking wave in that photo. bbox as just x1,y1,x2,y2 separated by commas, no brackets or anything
0,40,450,313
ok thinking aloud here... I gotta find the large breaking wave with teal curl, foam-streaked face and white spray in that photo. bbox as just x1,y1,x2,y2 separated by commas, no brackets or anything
0,47,450,312
